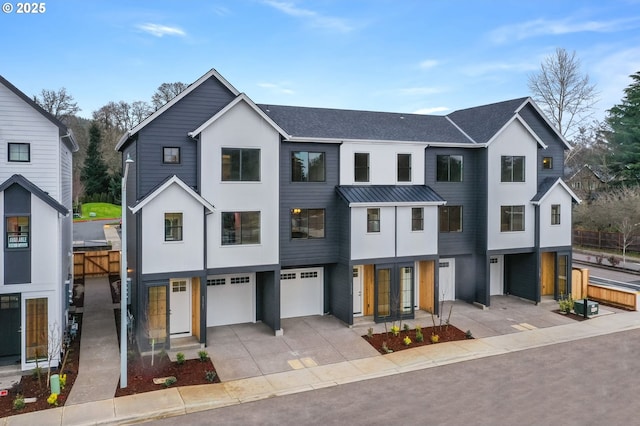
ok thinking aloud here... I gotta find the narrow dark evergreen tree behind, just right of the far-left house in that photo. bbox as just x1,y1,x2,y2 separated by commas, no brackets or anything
80,123,110,199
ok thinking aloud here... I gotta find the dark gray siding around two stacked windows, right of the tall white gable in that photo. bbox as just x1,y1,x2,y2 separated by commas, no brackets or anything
280,142,340,267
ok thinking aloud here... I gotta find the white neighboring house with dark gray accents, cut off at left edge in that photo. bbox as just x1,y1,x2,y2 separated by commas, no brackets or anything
0,76,78,370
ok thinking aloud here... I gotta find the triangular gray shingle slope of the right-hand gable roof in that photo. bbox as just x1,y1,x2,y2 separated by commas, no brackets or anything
447,98,528,143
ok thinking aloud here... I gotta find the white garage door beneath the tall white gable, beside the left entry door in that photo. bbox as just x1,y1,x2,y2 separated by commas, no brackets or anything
207,274,256,327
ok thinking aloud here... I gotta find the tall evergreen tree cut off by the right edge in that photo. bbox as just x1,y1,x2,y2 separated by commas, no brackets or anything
607,71,640,184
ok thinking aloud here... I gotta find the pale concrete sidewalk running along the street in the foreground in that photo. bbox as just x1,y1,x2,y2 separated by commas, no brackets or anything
5,306,640,426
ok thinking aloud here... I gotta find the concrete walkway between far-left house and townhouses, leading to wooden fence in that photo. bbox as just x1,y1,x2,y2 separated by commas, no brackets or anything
64,277,120,406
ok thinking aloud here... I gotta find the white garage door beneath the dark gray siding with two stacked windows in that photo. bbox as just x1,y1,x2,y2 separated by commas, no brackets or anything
280,268,324,318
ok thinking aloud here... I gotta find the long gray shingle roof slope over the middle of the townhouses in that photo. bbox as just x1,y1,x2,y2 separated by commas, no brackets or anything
258,104,473,144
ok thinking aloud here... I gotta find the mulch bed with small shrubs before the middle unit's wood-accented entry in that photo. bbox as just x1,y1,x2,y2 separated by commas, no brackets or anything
362,325,473,355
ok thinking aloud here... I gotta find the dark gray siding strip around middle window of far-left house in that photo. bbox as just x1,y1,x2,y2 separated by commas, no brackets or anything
2,183,33,284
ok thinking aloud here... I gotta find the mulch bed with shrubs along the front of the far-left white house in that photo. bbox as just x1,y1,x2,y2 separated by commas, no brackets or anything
0,314,82,418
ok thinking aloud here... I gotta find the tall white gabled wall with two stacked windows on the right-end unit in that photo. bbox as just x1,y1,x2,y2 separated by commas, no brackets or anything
487,121,538,250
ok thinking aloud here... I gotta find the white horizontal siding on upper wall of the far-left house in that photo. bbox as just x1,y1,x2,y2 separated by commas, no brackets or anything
0,84,62,206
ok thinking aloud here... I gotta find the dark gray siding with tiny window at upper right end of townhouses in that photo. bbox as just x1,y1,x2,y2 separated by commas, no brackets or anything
520,105,565,185
